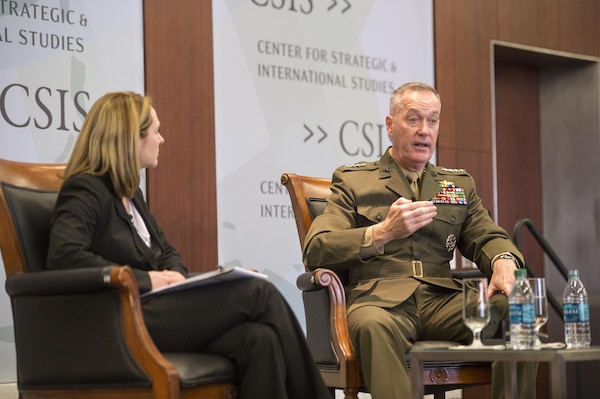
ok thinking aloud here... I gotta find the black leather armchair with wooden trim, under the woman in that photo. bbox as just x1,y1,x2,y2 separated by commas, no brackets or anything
0,160,236,399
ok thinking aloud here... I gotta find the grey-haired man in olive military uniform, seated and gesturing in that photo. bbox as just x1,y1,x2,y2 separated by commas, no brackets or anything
303,83,536,399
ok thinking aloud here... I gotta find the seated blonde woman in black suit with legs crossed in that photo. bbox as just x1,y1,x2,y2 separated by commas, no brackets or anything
48,92,330,399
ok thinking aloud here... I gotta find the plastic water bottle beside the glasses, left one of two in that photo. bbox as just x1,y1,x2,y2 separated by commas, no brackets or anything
508,269,536,350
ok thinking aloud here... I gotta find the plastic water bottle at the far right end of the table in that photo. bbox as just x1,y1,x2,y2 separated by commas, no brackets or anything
563,270,592,349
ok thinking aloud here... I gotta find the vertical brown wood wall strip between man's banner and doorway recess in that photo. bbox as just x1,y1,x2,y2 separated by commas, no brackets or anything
434,0,497,209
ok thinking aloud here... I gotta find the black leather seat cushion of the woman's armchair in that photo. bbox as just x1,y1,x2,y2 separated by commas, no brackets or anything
163,353,236,388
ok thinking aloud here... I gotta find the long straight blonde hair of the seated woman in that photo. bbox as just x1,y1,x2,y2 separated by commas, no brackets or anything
64,91,152,198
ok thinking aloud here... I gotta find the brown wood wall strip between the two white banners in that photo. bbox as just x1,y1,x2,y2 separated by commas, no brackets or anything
144,0,218,271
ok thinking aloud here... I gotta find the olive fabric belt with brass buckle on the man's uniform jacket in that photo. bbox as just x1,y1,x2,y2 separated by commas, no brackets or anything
350,260,452,281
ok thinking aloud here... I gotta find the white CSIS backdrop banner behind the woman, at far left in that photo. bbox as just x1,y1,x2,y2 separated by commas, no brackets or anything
0,0,144,383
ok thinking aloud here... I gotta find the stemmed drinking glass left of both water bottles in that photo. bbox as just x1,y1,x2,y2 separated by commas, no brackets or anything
463,278,490,349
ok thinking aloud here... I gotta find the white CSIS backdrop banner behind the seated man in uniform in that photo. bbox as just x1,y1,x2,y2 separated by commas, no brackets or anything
213,0,434,323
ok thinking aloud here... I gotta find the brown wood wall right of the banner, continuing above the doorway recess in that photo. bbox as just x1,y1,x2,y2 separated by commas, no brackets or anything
434,0,600,219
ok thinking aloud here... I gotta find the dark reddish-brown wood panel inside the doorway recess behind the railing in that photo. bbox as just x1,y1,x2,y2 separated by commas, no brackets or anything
495,62,544,276
